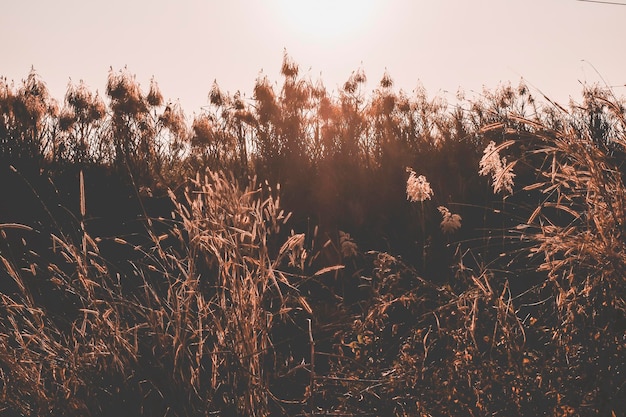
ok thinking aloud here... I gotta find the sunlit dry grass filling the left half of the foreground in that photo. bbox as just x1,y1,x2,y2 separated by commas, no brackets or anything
0,167,311,416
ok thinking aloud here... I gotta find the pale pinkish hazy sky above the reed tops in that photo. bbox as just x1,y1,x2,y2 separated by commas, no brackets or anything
0,0,626,115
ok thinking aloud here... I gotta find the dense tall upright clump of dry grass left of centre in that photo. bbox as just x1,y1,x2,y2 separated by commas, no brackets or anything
145,169,301,416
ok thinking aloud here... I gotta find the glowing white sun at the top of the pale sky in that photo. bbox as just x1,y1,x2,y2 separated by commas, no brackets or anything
276,0,381,41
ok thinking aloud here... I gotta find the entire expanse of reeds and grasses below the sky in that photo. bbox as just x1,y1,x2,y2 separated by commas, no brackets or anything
0,56,626,416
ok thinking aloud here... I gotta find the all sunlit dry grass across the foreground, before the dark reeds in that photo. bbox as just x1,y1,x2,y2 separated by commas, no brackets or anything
0,84,626,416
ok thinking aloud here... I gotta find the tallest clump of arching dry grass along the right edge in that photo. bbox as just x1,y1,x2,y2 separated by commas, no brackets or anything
470,88,626,415
